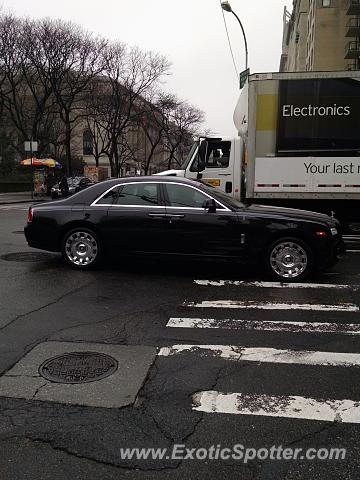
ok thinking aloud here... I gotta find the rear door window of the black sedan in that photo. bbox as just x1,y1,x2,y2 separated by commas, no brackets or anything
115,182,159,207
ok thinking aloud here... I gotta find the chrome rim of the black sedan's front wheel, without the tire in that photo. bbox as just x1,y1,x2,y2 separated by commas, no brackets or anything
270,241,309,279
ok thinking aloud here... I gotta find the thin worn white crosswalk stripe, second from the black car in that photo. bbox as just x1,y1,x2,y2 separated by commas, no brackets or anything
183,300,359,312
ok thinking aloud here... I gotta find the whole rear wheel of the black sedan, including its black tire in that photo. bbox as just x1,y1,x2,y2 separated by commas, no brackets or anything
61,226,102,270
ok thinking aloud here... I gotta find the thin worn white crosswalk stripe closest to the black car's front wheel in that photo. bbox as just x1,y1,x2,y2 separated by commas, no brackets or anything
194,280,360,290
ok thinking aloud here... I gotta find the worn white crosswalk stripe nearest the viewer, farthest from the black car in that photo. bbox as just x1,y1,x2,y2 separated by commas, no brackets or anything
192,390,360,423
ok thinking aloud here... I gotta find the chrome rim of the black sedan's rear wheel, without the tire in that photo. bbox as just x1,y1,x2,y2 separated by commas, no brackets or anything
65,231,99,267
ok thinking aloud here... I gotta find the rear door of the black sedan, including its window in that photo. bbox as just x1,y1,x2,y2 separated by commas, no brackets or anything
102,181,168,254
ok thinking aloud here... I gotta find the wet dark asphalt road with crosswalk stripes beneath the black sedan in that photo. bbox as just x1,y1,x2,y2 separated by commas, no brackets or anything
0,205,360,480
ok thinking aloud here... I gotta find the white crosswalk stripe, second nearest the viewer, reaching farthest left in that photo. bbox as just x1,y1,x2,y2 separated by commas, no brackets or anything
159,345,360,367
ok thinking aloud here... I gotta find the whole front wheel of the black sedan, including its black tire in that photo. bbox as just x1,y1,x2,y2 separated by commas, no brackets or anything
266,237,313,282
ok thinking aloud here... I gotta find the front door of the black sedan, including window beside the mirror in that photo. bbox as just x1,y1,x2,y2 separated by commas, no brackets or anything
163,182,245,258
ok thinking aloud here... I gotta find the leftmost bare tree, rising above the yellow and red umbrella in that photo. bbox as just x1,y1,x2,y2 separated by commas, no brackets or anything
0,15,65,158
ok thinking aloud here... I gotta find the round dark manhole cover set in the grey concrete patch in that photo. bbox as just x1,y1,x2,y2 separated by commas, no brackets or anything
39,352,118,383
